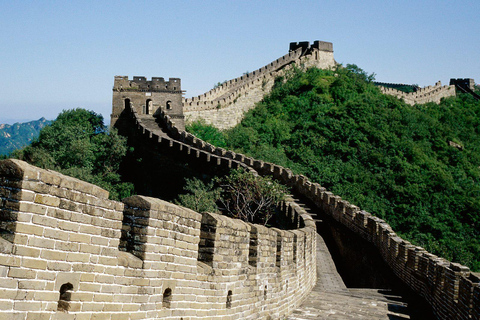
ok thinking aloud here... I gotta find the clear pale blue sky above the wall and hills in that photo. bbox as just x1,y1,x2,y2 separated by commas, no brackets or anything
0,0,480,123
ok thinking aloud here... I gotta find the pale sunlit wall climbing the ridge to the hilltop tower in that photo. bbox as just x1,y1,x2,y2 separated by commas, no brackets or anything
183,41,335,129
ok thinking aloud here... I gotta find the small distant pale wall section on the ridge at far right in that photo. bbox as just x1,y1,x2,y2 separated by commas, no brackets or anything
380,81,455,106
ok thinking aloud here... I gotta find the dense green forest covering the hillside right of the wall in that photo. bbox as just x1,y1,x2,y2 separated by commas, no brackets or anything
187,65,480,271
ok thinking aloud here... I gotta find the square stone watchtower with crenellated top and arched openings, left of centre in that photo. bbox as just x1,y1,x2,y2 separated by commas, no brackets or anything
110,76,185,130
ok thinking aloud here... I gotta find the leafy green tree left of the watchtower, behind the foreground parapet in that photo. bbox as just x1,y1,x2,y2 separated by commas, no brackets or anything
13,109,133,199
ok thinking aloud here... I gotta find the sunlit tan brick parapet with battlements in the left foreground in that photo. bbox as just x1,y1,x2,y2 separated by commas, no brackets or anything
0,159,316,320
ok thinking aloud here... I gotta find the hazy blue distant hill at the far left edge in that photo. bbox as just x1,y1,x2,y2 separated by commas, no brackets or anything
0,118,51,155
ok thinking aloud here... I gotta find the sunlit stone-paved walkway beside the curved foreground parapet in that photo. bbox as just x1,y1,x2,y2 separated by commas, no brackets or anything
287,201,410,320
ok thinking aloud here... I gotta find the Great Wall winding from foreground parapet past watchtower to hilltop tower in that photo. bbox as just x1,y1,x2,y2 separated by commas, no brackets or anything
0,43,480,320
